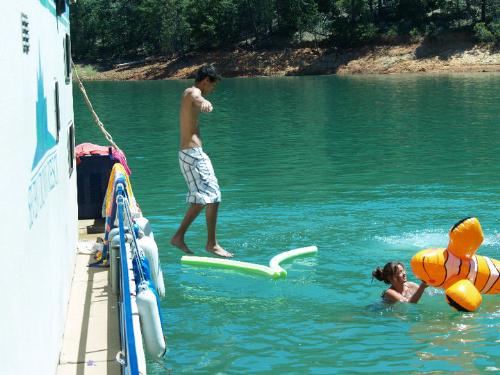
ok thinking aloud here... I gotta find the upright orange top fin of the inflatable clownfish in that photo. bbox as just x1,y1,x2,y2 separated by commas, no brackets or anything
447,217,484,259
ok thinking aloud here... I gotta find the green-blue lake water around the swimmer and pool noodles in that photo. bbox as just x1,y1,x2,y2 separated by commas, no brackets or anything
74,74,500,374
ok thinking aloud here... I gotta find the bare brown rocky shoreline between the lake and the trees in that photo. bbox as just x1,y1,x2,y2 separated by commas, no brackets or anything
77,38,500,80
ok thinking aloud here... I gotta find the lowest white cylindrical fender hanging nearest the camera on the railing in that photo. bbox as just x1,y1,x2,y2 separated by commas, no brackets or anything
137,283,167,359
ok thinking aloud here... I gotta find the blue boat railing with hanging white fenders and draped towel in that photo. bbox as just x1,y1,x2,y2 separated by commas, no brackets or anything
103,163,167,375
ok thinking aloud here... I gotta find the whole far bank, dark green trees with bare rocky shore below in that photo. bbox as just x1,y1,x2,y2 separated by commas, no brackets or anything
71,0,500,79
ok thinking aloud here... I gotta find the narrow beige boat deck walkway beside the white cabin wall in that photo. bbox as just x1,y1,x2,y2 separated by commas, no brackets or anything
56,220,121,375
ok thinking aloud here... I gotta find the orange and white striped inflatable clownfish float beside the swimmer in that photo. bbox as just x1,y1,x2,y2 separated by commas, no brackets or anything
411,217,500,311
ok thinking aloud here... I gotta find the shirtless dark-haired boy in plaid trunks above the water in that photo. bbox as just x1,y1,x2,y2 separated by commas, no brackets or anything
170,65,233,258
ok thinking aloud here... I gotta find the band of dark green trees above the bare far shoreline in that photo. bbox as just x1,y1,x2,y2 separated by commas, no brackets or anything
70,0,500,62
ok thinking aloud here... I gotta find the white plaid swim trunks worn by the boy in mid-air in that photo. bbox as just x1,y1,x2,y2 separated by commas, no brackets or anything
179,147,221,204
